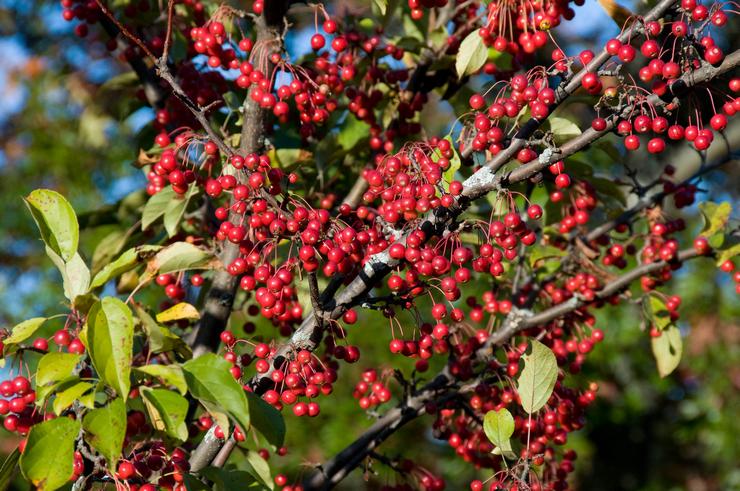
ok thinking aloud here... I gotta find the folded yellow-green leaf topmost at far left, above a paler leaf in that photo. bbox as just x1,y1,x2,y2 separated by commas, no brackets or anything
26,189,80,262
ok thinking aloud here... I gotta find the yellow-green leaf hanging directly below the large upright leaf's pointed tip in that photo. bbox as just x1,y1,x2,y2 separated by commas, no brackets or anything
82,397,126,472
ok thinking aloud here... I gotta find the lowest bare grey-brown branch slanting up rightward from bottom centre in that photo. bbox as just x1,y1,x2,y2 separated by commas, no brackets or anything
303,249,698,491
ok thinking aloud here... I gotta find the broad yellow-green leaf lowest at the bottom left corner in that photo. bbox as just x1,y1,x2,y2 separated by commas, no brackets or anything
20,418,80,491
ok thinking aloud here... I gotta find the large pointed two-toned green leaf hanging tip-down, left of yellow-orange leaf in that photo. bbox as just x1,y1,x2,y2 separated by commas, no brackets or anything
83,297,134,400
